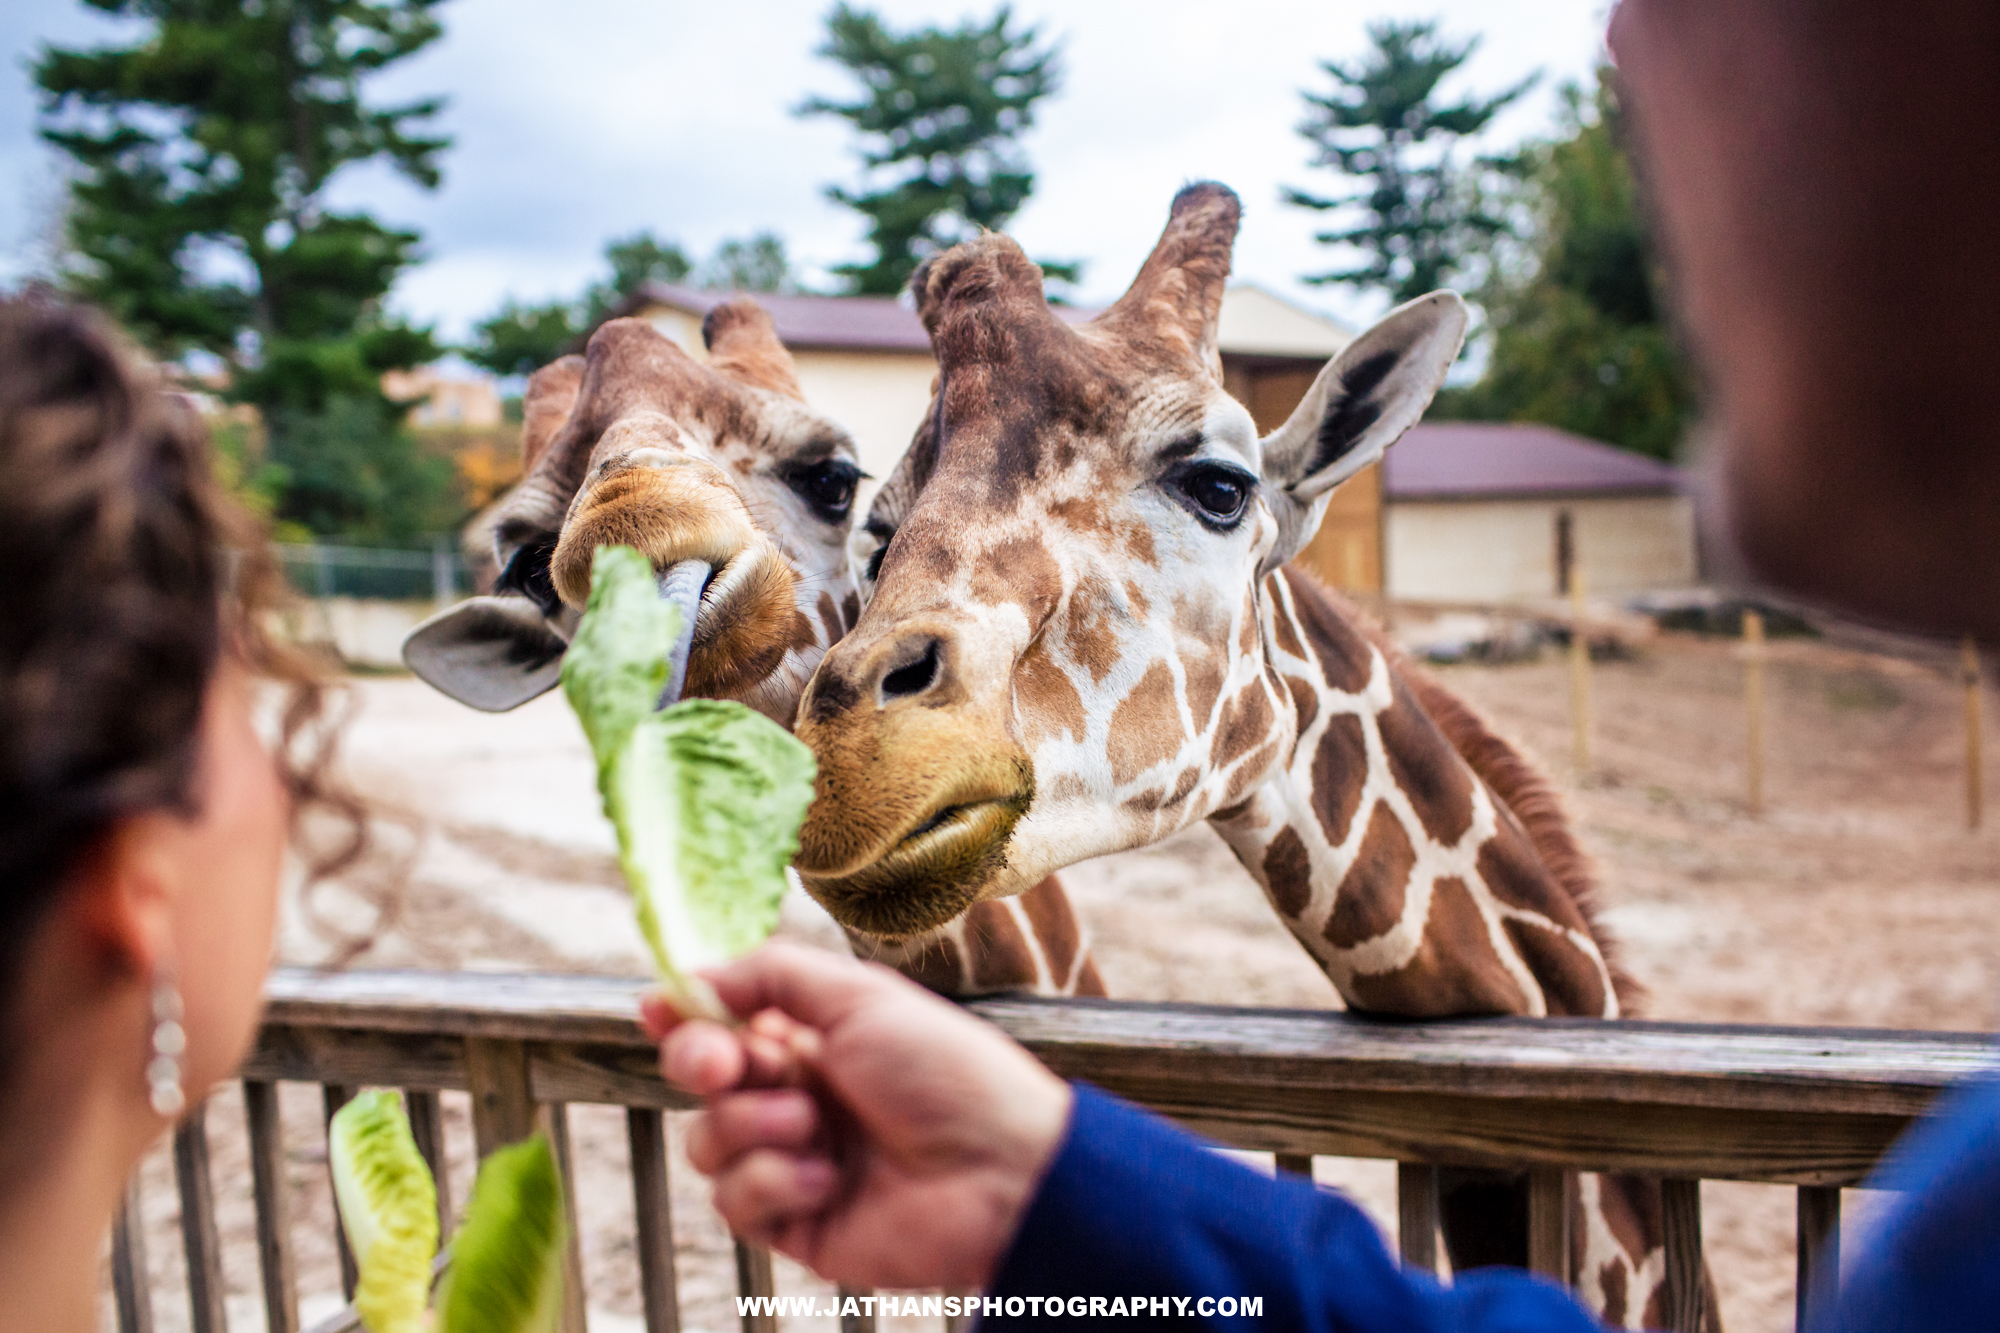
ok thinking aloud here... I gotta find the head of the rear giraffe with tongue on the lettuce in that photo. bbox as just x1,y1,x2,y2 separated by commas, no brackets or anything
404,300,862,725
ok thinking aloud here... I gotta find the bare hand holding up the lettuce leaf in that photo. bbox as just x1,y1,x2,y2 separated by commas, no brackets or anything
642,932,1070,1289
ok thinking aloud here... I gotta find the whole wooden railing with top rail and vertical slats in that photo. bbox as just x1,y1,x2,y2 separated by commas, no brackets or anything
112,971,1990,1333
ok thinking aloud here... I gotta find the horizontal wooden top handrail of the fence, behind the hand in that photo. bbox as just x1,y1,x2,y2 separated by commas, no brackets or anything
246,971,1992,1185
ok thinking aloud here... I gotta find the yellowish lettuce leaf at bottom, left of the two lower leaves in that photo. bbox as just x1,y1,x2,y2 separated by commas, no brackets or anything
326,1089,438,1333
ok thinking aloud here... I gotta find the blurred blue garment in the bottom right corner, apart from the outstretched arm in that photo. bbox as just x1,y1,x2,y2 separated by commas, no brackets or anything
1812,1079,2000,1333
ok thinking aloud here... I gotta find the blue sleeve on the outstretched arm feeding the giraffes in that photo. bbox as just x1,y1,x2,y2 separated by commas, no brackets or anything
980,1085,1598,1333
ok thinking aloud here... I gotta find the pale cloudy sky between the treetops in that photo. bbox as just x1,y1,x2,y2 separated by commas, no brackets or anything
0,0,1606,336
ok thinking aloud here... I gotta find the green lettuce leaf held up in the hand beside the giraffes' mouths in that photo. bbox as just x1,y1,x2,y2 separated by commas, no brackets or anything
562,546,814,1019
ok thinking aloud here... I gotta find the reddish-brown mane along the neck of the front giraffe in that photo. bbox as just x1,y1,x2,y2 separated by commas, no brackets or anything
1314,578,1646,1019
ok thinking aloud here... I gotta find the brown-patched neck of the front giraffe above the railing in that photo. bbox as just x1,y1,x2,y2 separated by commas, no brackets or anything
1212,568,1620,1017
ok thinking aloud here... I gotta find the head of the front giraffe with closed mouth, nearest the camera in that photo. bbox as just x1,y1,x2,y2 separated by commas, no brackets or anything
798,184,1466,937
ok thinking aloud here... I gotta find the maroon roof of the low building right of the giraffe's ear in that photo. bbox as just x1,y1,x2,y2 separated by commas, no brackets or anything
1382,420,1680,500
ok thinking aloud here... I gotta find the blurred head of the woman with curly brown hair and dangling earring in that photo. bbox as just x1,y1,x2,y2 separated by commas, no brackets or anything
0,300,346,1179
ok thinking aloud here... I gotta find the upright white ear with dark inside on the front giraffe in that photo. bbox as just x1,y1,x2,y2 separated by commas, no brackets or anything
1262,292,1466,566
